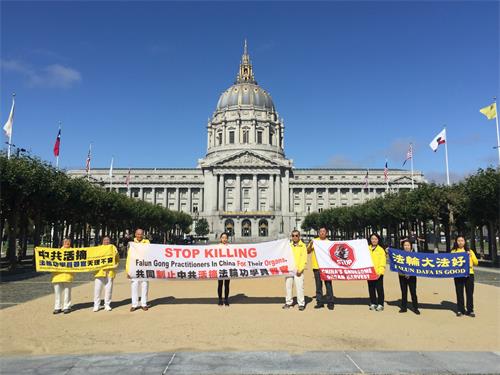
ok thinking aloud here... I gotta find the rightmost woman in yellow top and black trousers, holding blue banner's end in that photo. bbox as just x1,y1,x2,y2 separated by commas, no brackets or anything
451,235,479,318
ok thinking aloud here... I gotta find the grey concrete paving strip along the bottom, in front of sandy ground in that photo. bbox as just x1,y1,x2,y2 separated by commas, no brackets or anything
0,351,500,375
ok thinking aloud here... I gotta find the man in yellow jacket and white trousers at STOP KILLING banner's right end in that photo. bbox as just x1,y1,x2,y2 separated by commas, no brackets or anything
283,230,307,311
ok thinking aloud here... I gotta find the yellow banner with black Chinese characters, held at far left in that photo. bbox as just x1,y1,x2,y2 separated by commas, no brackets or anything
35,245,117,272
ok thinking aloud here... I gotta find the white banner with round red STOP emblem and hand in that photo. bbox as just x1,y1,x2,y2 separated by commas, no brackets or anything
314,240,378,280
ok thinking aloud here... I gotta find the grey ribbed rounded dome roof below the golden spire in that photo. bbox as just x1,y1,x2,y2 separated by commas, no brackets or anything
217,83,274,112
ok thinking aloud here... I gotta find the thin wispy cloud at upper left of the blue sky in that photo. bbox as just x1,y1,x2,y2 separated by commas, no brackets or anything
0,60,82,89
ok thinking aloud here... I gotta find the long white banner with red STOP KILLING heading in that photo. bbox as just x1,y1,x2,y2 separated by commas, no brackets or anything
127,239,295,280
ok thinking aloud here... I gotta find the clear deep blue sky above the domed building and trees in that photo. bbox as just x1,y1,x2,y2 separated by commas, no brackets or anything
0,1,500,182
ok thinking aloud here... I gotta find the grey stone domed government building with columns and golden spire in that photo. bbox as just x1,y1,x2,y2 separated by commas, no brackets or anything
68,42,424,241
